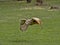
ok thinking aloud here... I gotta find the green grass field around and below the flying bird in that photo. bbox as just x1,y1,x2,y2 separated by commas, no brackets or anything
0,1,60,45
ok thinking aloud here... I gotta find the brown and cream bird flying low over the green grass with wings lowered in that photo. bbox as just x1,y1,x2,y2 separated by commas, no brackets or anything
20,17,41,31
